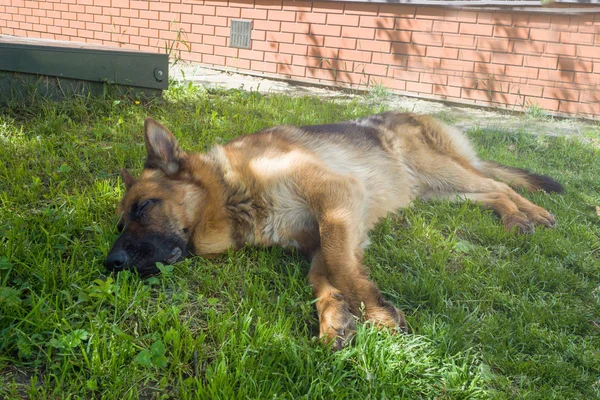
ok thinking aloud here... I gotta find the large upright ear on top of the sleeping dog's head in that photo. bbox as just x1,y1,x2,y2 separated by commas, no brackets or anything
144,118,185,175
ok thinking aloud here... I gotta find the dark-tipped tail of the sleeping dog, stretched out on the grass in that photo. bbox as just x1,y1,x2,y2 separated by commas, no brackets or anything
479,160,564,193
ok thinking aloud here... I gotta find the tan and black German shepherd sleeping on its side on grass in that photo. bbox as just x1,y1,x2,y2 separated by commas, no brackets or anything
106,112,562,347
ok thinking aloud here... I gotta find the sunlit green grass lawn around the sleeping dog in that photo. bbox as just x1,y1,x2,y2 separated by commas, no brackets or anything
0,86,600,399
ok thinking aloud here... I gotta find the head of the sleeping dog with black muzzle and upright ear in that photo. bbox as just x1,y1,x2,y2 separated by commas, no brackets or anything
105,118,203,276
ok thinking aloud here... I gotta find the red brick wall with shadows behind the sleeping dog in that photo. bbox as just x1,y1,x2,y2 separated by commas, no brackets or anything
0,0,600,117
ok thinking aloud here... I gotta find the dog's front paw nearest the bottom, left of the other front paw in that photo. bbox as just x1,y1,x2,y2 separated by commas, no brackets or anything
317,293,356,350
